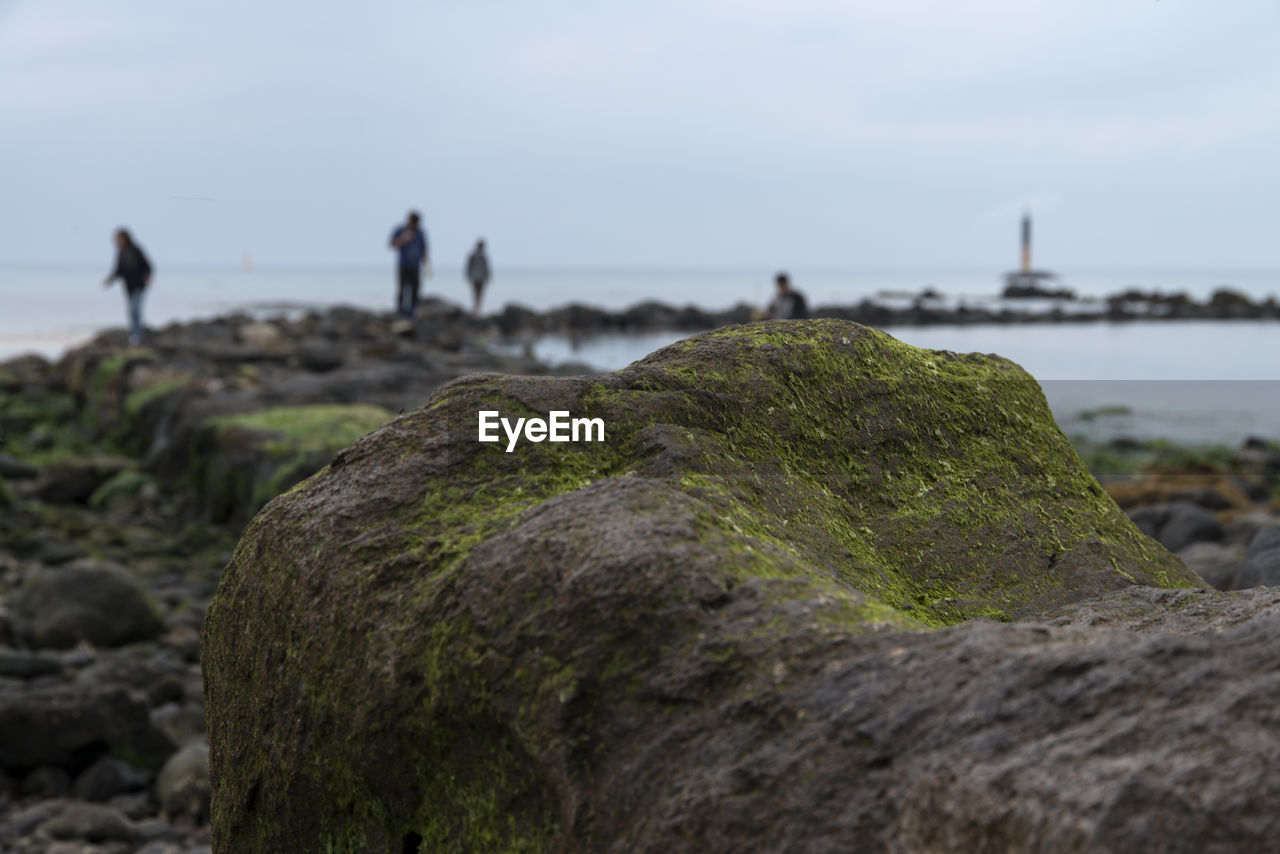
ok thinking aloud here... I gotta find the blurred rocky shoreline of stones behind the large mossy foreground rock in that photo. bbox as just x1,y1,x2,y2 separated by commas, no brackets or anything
0,302,1280,854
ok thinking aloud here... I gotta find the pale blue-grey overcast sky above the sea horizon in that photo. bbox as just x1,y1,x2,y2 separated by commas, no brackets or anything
0,0,1280,270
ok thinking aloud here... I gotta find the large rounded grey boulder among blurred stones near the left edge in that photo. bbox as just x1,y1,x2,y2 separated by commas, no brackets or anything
14,558,164,649
